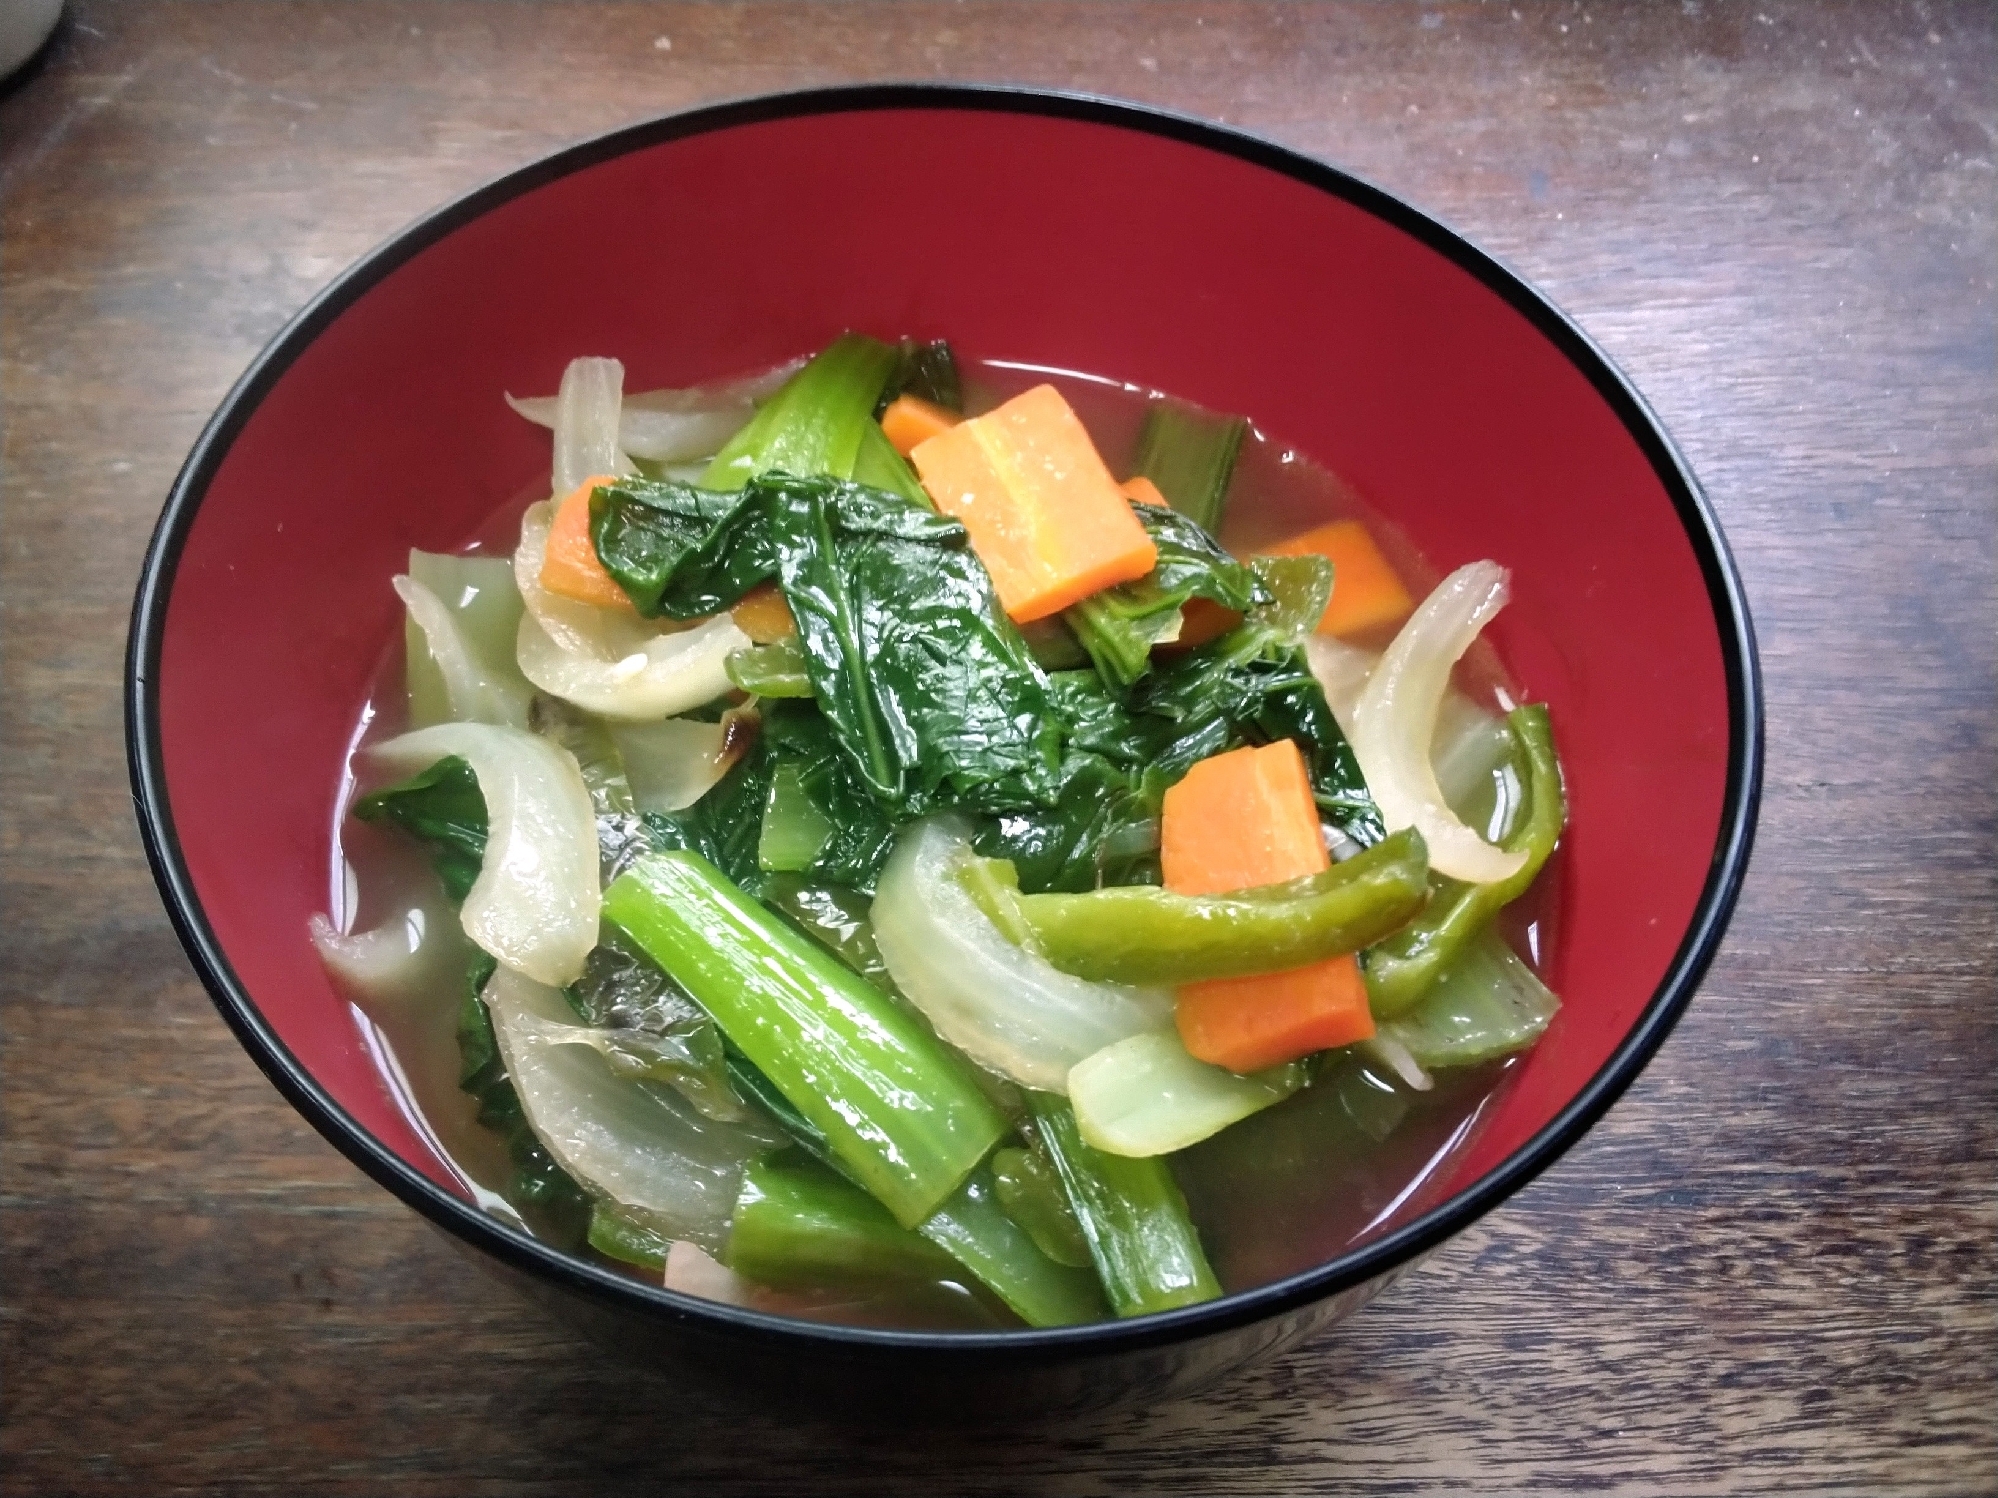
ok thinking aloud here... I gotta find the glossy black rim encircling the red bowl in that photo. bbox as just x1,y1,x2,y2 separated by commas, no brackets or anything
126,82,1762,1364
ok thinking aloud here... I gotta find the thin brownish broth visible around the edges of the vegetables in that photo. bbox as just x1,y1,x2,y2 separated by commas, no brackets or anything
330,364,1560,1328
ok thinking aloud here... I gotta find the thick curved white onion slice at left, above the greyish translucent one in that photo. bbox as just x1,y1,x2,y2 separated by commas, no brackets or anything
368,723,603,987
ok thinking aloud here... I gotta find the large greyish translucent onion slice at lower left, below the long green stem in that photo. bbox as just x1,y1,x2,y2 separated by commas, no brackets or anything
486,967,781,1252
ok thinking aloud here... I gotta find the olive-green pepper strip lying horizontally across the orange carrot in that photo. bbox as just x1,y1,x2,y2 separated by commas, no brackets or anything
987,827,1429,985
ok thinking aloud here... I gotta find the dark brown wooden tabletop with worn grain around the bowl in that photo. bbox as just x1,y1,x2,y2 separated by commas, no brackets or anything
0,0,1998,1496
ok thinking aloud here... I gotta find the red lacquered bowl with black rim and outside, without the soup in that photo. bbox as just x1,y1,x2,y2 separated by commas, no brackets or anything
128,86,1760,1408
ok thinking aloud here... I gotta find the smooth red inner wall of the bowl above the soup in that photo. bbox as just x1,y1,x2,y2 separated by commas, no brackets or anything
144,106,1730,1326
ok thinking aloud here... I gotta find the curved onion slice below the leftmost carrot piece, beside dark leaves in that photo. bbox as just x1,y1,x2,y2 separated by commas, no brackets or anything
513,501,749,721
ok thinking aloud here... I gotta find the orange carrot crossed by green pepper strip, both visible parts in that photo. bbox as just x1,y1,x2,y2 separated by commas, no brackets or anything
1159,739,1373,1071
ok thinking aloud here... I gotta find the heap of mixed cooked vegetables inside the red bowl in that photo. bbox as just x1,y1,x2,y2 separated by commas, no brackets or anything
312,334,1566,1326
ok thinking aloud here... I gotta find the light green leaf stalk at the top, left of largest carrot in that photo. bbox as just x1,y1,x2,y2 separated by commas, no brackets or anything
699,334,901,491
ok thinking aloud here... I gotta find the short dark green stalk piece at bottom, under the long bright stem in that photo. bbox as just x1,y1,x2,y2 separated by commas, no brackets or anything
727,1152,957,1290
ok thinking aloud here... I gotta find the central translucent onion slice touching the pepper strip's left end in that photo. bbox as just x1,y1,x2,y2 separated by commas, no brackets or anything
873,819,1173,1093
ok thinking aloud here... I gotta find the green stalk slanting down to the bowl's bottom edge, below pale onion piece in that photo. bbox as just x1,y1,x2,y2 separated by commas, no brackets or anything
1027,1093,1221,1316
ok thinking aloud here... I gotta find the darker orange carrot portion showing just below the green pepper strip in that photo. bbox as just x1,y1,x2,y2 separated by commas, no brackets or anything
1173,953,1375,1073
